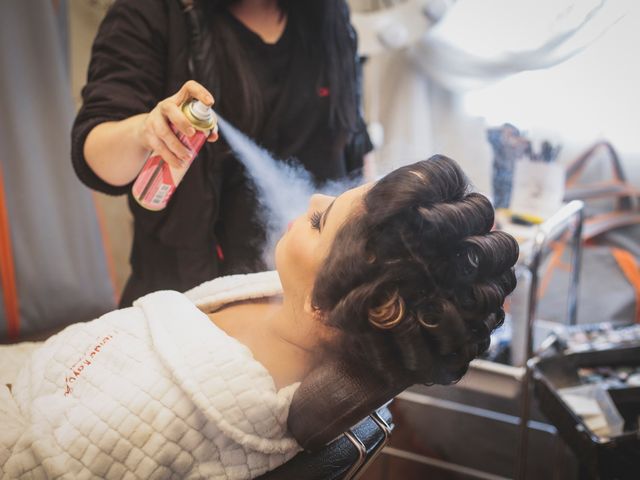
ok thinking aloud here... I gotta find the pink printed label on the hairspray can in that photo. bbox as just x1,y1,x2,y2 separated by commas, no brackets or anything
132,125,208,210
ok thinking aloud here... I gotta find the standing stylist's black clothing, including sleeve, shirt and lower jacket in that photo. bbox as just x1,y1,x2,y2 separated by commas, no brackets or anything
72,0,370,306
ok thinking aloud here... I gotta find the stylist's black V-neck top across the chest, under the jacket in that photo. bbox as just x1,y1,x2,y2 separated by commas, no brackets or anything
220,9,356,182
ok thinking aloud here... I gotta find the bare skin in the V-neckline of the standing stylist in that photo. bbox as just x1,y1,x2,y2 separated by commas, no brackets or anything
229,0,287,43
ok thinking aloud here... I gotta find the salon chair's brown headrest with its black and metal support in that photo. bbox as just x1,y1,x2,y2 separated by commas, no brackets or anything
258,363,410,480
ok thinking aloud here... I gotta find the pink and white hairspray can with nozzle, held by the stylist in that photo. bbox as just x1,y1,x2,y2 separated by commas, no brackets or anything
132,99,217,210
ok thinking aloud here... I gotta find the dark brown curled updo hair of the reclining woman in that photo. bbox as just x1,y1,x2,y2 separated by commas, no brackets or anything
312,155,518,384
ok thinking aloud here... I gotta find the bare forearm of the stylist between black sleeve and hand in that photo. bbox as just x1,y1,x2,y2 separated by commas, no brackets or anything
84,113,149,186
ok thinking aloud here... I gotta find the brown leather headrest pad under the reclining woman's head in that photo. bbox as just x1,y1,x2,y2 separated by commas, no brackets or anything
288,362,410,451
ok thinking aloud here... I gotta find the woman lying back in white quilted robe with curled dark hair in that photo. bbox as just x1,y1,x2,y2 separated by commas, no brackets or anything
0,156,518,478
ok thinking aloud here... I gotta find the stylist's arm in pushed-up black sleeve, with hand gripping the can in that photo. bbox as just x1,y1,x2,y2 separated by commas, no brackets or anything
72,0,217,194
